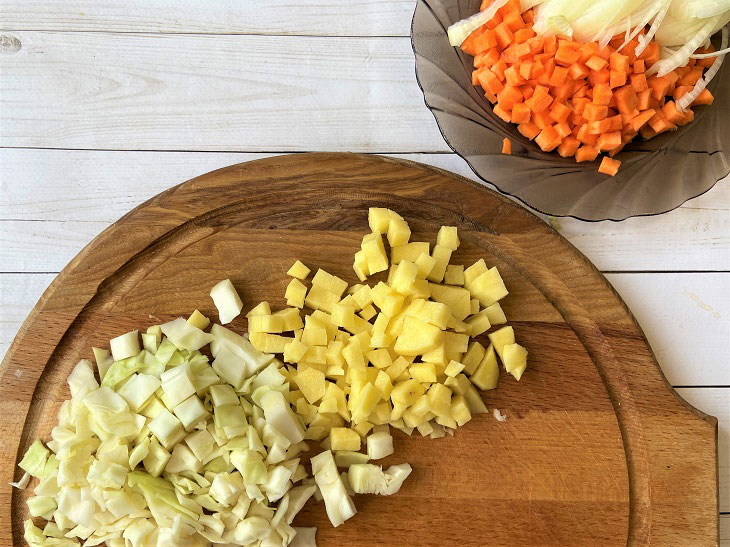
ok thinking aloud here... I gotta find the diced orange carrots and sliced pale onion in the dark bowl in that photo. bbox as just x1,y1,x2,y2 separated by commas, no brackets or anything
449,0,730,175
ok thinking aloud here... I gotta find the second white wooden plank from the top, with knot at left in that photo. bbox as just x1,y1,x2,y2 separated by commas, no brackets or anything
0,32,449,152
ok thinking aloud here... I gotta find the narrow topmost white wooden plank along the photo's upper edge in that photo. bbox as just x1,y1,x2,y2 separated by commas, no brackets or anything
0,0,415,36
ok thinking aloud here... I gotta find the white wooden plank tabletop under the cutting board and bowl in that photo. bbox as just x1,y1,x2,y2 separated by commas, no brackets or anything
0,0,730,545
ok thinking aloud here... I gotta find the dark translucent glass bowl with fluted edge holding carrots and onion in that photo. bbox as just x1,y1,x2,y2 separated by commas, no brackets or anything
411,0,730,221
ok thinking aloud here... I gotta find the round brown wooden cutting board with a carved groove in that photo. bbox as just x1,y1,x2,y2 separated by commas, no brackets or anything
0,154,718,547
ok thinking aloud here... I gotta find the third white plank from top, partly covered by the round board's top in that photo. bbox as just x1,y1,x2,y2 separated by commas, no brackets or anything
0,149,730,272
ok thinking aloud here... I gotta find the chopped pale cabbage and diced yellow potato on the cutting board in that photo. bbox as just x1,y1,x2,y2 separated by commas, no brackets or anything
13,208,527,547
